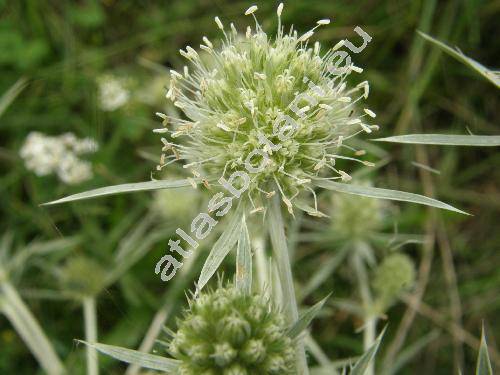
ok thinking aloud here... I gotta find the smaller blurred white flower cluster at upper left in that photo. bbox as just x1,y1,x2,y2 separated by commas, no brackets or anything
97,74,130,112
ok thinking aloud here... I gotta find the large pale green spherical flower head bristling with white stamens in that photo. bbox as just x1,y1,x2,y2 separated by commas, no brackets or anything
156,4,378,212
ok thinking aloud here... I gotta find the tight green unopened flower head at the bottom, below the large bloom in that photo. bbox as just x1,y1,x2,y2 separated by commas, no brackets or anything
168,286,295,375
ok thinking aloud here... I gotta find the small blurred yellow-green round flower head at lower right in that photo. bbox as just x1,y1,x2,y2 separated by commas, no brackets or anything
372,253,415,309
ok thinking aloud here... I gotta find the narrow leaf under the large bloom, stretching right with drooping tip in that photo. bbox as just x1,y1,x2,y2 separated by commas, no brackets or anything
314,180,469,215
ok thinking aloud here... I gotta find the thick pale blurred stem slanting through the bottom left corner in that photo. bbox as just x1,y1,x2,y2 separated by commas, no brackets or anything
0,280,66,375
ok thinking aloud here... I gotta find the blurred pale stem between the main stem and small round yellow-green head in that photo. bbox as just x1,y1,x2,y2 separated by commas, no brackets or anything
354,248,377,375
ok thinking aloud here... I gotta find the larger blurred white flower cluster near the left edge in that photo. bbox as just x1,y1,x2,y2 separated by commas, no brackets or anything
19,132,98,185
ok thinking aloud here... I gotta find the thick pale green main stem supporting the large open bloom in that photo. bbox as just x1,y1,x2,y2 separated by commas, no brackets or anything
269,194,309,375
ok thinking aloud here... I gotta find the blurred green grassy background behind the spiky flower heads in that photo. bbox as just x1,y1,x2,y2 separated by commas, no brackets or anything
0,0,500,374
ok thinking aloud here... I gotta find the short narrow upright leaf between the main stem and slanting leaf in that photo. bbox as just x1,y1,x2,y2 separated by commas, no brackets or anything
236,215,252,294
